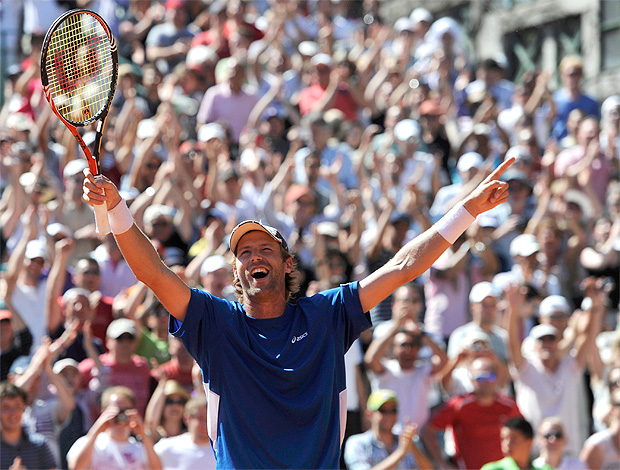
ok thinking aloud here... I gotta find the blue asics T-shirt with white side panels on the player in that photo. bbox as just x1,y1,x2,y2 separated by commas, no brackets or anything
170,282,371,468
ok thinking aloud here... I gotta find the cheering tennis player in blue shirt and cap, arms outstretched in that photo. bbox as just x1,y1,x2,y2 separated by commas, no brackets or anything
84,159,513,468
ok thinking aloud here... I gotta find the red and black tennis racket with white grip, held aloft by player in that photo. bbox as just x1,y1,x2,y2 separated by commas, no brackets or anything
41,9,118,239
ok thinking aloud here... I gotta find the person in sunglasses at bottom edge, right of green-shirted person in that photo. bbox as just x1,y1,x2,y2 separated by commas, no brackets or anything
532,417,588,470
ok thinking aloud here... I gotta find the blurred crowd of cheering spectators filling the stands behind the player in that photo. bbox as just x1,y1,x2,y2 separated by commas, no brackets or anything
0,0,620,470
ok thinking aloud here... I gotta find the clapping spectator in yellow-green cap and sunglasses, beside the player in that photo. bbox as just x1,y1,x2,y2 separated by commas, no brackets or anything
344,389,433,470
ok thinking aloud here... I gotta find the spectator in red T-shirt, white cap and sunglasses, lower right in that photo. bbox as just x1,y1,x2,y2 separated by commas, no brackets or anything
421,358,521,469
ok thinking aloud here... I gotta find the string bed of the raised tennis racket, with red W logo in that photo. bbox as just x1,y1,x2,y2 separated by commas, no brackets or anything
46,14,114,123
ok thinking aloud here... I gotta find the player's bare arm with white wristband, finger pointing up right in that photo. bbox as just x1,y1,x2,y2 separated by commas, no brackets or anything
359,159,514,312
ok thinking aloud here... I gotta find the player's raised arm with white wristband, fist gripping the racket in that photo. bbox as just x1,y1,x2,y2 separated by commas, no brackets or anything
84,170,190,321
